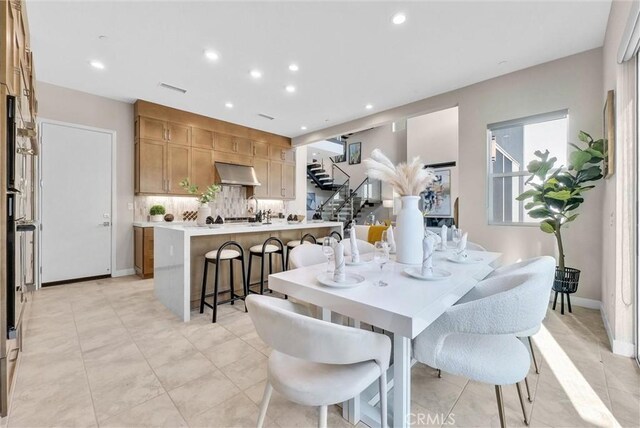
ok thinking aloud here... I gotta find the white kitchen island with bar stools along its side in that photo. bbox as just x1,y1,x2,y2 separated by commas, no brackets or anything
153,220,343,321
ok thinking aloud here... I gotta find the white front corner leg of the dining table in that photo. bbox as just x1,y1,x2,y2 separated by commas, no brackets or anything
393,333,411,427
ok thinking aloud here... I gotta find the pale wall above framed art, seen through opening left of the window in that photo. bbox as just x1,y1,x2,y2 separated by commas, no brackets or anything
407,107,460,210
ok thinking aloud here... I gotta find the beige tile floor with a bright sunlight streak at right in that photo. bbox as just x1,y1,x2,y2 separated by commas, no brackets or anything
2,277,640,427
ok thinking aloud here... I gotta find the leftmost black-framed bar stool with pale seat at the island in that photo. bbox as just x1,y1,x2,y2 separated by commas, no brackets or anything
200,241,247,322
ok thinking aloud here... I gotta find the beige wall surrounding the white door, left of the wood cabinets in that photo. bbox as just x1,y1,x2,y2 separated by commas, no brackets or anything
37,82,134,275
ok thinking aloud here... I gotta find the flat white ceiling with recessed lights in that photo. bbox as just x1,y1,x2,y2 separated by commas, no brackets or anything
26,0,610,137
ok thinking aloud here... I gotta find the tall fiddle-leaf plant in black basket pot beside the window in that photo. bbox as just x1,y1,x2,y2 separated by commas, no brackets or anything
516,131,606,313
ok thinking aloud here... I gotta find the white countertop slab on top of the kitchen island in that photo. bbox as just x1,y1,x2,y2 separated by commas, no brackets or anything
153,221,342,236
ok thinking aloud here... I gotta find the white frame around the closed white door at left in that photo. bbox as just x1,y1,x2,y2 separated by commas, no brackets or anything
36,118,117,289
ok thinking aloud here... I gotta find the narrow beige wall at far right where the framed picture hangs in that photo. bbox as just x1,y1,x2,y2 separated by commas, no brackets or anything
600,0,634,352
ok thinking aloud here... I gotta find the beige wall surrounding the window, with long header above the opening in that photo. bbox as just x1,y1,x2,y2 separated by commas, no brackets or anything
293,48,603,300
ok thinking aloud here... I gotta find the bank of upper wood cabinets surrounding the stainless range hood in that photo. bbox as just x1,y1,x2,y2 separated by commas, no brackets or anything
134,100,296,199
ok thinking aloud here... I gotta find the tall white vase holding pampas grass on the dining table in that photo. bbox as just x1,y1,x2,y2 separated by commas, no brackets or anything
394,196,424,265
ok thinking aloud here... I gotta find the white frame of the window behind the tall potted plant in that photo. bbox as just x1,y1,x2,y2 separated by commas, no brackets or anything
486,109,569,227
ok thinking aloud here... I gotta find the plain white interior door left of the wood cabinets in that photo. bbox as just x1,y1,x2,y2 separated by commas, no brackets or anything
41,122,113,284
